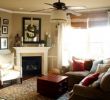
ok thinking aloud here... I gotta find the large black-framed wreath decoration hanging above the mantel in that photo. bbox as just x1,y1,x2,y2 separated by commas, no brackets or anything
22,17,41,43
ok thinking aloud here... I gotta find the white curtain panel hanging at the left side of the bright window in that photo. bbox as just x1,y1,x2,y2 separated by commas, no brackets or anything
57,15,71,68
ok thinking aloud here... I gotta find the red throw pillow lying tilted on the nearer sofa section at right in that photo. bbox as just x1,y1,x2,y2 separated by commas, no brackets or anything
80,73,99,86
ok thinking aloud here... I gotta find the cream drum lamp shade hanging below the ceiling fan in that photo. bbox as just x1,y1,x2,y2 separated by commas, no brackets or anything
51,10,67,23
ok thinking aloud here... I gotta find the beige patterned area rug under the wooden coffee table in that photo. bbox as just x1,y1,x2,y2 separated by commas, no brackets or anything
0,77,69,100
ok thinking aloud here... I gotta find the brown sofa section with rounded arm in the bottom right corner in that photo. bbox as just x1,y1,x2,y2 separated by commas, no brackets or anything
69,68,110,100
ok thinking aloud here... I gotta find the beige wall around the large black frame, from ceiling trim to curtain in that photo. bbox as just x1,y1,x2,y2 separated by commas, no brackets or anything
0,12,57,71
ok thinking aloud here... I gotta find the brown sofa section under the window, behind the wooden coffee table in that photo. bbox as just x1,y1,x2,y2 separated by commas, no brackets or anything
63,60,93,91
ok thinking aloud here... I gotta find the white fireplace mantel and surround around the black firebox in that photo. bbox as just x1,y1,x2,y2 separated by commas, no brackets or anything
13,47,50,75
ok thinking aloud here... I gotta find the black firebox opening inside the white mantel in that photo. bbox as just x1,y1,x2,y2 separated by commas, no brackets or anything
22,56,42,77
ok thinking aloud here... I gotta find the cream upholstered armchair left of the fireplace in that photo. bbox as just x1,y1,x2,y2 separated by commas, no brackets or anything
0,53,22,86
